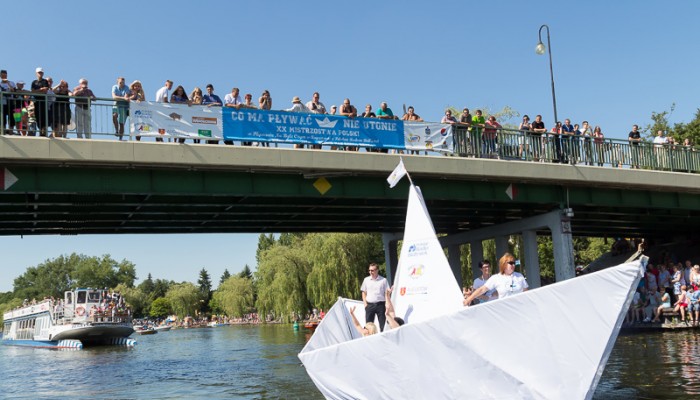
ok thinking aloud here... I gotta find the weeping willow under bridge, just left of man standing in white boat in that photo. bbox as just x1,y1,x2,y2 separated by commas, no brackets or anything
305,233,384,310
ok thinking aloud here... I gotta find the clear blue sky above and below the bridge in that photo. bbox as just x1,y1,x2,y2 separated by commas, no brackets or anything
0,0,700,291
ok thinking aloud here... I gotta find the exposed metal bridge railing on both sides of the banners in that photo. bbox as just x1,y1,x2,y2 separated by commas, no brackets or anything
0,92,700,172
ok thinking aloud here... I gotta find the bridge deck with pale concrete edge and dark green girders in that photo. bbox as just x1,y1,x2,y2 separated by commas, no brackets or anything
0,136,700,280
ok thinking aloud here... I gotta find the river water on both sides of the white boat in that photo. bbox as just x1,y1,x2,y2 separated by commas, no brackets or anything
0,325,700,400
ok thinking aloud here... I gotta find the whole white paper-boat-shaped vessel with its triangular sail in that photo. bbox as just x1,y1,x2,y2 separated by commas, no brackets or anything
299,184,646,400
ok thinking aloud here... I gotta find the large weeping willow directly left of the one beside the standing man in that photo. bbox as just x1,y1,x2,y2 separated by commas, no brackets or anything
255,243,311,322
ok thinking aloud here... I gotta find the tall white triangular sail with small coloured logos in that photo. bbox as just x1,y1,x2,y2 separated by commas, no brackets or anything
391,185,463,323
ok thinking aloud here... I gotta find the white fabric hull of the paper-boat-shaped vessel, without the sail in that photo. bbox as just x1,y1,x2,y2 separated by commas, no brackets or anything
299,261,643,400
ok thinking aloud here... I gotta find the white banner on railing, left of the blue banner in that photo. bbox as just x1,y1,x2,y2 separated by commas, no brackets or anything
129,101,224,140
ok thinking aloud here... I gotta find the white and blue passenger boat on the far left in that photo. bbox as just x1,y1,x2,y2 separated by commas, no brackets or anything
2,289,136,349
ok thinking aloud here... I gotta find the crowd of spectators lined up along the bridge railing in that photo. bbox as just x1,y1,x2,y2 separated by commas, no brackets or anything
0,67,693,168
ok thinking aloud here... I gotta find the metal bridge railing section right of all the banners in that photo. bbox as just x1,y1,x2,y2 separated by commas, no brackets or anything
454,125,700,172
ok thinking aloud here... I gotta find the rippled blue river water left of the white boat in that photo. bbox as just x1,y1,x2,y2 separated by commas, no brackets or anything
0,325,323,399
